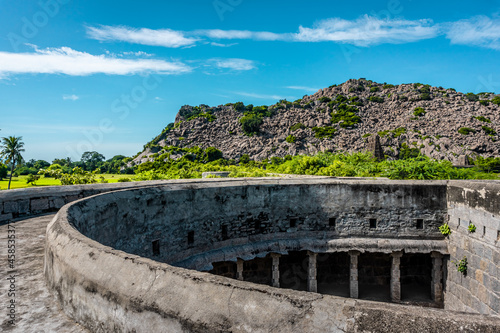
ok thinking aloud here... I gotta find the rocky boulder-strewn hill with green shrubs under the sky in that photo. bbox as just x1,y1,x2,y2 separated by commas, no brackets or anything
134,79,500,164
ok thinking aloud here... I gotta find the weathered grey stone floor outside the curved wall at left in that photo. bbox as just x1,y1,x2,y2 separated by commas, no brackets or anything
0,214,88,333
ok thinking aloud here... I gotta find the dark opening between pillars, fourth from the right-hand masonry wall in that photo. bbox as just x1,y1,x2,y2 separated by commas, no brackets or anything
280,251,308,291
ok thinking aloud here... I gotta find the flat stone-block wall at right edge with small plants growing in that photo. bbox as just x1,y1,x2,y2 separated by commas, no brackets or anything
444,181,500,315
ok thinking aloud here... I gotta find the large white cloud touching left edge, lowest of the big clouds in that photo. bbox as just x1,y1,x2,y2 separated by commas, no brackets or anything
0,47,191,78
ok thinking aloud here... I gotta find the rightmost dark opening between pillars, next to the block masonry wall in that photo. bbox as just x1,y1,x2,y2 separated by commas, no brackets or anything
401,253,432,303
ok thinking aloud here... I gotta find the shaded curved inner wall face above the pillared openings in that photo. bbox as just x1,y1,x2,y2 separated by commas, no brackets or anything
64,179,446,269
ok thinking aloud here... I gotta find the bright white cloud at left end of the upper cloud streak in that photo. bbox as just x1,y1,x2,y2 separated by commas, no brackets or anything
86,25,198,48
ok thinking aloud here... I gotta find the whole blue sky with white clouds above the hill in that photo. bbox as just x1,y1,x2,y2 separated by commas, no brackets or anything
0,0,500,161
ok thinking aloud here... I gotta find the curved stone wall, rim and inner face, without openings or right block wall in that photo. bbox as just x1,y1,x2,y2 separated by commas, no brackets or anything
45,179,500,332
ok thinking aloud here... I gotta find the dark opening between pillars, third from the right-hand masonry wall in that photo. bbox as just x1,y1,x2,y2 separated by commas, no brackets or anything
317,252,350,297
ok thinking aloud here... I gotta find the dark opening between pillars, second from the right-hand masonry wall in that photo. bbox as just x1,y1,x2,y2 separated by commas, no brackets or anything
358,253,392,302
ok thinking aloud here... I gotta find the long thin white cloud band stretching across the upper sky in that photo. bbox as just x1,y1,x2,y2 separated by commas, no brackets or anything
87,15,439,47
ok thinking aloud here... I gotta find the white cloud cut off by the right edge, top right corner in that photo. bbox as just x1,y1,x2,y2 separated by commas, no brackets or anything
446,16,500,50
